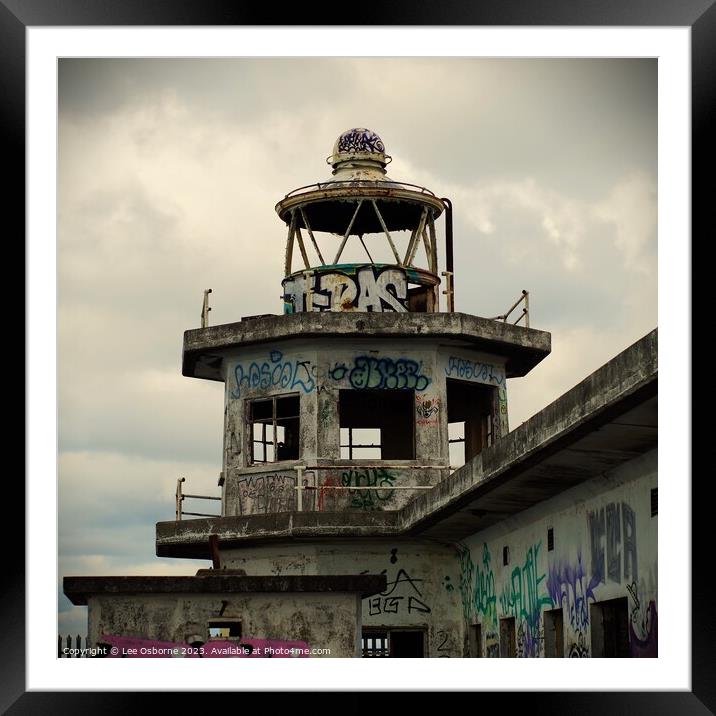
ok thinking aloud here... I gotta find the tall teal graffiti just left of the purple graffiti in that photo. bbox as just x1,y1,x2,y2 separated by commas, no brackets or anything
500,542,552,656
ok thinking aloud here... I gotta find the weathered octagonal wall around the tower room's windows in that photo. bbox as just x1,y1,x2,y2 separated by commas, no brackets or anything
222,340,507,516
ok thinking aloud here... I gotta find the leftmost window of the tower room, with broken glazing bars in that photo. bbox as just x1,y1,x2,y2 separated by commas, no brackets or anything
247,395,300,464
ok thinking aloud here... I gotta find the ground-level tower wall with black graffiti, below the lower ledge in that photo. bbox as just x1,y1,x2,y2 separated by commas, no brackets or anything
221,540,464,657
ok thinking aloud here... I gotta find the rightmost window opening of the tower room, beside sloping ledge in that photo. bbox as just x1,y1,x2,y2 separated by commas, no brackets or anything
446,378,496,468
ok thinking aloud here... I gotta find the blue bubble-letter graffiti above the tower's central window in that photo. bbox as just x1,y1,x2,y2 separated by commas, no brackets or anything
328,356,430,391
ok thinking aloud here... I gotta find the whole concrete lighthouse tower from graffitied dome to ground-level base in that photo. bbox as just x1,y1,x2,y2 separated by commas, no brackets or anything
148,128,550,655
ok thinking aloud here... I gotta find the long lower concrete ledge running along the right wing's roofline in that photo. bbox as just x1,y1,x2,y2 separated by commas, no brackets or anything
156,330,658,558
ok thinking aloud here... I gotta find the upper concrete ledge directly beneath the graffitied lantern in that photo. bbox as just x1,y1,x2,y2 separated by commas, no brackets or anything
182,311,552,380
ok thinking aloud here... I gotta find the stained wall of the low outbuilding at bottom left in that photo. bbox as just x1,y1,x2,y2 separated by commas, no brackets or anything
87,593,360,658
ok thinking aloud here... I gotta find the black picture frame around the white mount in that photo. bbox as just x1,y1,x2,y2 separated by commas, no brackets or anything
0,0,704,716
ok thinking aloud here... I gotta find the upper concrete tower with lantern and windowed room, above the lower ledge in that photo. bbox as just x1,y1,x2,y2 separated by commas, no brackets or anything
178,128,549,517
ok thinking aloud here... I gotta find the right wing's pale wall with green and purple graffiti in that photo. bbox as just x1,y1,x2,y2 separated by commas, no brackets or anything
458,450,658,657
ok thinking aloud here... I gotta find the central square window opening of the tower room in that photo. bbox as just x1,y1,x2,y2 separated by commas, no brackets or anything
338,390,415,460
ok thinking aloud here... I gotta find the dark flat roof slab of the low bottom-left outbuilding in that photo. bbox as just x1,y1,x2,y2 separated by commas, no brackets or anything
62,570,386,605
